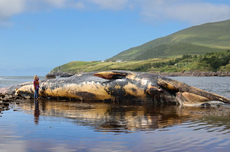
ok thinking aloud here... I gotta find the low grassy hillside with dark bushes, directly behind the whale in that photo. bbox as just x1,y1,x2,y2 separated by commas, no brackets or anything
51,50,230,73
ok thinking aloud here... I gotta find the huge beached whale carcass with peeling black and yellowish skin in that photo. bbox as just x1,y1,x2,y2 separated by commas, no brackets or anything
0,70,230,105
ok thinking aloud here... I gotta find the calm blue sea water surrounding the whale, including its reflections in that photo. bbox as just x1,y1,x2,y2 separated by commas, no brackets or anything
0,77,230,152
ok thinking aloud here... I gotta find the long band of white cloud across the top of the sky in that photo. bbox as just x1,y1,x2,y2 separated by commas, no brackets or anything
0,0,230,26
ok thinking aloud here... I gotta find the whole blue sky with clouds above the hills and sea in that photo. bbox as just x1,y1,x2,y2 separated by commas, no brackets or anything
0,0,230,76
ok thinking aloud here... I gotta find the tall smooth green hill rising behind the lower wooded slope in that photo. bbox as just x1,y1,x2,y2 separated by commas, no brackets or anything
107,20,230,61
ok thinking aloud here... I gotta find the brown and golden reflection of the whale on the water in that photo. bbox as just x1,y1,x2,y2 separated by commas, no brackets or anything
15,100,229,132
